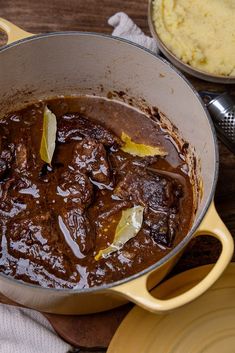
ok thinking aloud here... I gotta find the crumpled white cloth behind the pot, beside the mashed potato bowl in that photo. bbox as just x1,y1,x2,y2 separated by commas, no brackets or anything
108,12,159,54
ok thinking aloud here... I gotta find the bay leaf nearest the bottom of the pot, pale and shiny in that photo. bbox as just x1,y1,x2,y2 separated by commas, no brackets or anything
95,206,144,261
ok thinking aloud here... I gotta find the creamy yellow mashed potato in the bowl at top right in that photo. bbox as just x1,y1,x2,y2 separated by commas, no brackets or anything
153,0,235,76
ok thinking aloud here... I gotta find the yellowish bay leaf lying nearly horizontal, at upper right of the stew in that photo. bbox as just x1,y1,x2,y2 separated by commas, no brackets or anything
121,132,168,157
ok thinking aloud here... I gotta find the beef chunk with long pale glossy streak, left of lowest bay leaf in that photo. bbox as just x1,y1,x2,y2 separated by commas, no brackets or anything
58,208,95,259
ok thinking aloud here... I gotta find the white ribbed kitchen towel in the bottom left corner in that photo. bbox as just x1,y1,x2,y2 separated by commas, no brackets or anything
0,304,71,353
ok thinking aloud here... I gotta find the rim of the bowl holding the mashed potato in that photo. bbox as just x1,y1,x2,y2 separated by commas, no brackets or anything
148,0,235,84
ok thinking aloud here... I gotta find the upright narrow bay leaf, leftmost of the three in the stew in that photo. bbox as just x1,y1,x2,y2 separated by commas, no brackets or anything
40,106,57,164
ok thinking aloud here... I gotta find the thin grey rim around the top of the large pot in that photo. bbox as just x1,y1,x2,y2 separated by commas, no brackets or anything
0,31,219,295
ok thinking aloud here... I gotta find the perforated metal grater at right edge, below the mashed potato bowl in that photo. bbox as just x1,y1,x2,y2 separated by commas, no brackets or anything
199,91,235,153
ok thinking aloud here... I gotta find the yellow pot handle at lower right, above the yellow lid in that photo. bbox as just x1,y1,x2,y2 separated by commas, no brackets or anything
111,202,234,313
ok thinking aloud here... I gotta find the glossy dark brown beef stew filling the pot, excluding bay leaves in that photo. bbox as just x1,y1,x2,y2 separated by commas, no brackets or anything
0,96,193,289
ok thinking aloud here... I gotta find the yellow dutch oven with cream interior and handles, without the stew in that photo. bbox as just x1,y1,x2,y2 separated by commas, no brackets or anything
0,19,233,314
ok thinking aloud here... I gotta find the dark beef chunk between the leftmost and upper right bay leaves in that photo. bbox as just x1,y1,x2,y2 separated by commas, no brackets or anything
57,114,122,147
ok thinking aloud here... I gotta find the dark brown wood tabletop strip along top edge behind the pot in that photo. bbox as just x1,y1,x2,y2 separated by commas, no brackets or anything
0,0,148,33
